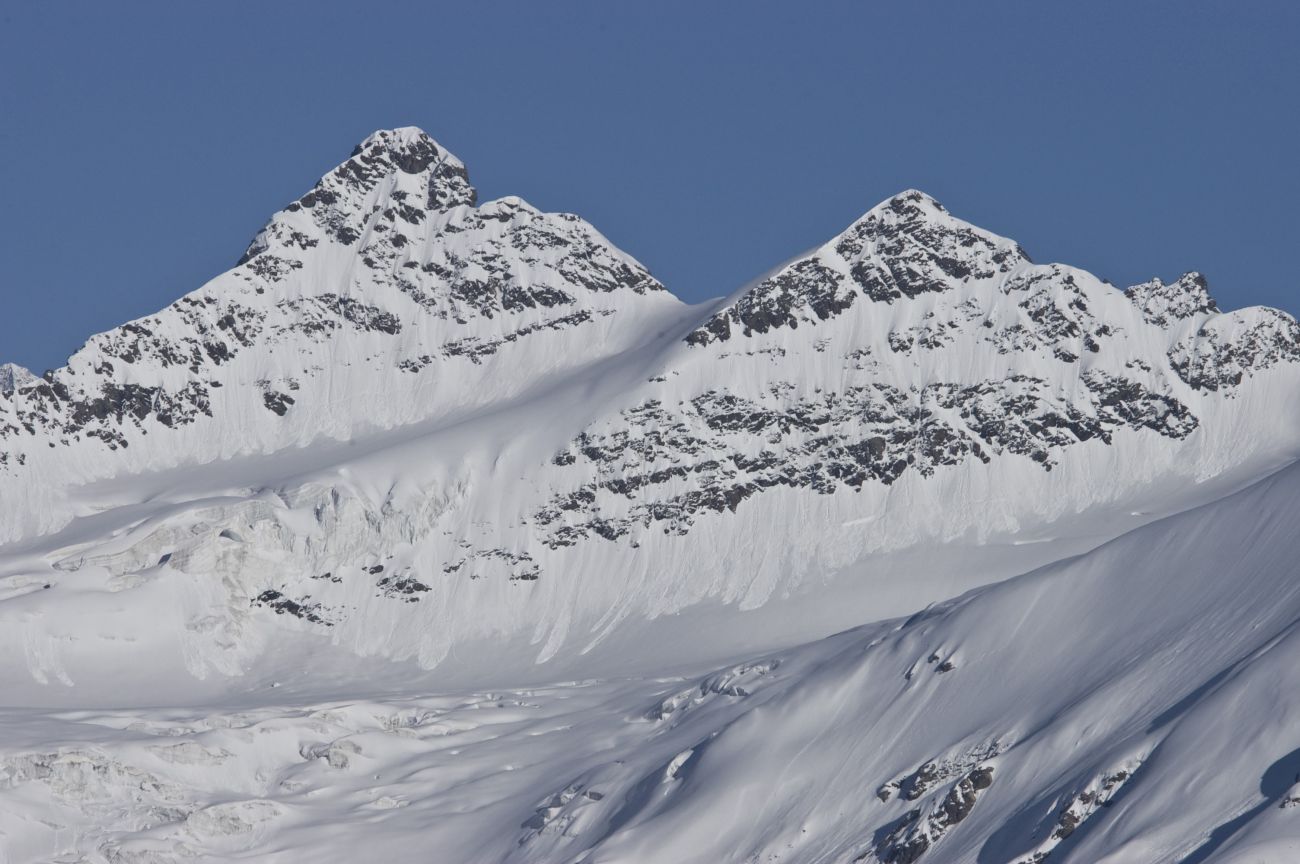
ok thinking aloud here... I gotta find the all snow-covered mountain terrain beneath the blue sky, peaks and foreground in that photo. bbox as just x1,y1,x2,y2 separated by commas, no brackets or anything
0,129,1300,863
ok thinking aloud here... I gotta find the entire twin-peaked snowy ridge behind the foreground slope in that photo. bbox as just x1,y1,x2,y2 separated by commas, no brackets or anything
0,129,1300,686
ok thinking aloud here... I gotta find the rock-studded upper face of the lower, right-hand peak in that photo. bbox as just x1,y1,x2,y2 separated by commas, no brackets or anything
535,192,1300,542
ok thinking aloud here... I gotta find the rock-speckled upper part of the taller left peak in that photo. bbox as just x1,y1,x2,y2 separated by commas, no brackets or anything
0,130,664,469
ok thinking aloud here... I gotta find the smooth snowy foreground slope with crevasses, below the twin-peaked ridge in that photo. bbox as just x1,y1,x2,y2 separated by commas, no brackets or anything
0,454,1300,864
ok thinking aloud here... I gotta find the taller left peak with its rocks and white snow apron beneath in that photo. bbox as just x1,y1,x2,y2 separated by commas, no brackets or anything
0,129,681,540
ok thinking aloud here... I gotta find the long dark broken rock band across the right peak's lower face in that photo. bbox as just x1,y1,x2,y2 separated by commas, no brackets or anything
534,372,1199,548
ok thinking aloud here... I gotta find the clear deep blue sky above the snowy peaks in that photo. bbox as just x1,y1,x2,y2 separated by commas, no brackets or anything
0,0,1300,372
